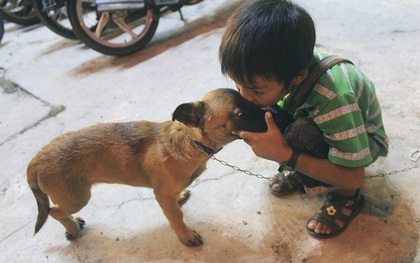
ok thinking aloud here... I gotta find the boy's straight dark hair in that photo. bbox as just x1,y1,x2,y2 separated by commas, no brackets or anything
219,0,315,87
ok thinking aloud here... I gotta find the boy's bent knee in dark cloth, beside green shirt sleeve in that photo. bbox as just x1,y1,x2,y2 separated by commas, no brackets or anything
285,118,329,158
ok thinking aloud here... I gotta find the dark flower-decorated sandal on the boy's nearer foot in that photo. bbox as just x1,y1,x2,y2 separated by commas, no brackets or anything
306,189,364,239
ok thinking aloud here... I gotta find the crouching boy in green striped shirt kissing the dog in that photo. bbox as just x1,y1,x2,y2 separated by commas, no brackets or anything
219,0,388,238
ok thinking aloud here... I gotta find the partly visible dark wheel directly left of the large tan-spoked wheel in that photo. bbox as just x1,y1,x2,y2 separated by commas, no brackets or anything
32,0,78,39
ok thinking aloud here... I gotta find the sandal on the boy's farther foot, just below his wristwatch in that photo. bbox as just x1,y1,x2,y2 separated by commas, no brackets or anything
269,169,304,197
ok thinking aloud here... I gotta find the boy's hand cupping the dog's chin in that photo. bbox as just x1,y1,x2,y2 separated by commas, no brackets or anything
233,112,293,163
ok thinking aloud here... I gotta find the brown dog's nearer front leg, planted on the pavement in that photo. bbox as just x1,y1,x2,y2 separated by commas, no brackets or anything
154,189,203,247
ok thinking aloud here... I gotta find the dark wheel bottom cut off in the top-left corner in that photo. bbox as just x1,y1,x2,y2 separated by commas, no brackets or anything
0,0,39,26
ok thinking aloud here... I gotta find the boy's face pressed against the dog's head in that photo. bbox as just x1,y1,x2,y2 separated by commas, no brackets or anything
231,76,289,107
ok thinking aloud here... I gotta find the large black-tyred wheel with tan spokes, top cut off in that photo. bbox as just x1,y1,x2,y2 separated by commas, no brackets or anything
67,0,159,56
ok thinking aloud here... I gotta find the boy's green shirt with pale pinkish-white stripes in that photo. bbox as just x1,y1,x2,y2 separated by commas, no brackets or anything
279,52,388,167
